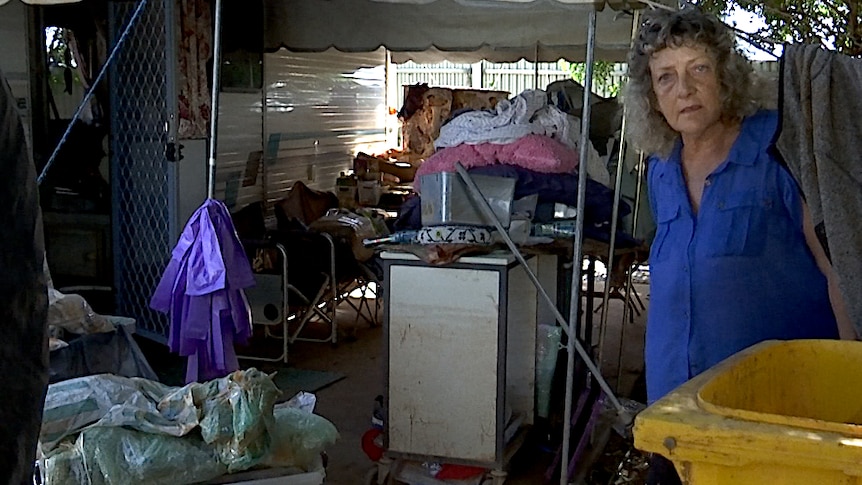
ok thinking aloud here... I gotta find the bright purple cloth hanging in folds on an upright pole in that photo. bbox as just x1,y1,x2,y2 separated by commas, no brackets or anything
150,199,254,383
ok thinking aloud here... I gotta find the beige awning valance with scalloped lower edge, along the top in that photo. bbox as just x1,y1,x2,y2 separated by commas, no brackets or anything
264,0,676,62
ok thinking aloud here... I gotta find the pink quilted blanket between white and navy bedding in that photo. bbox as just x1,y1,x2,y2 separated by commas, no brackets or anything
413,135,578,192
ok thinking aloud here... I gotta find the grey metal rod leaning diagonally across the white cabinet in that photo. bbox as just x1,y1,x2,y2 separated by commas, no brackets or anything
455,162,625,413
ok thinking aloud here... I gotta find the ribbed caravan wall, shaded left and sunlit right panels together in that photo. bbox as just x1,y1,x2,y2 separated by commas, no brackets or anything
216,49,388,212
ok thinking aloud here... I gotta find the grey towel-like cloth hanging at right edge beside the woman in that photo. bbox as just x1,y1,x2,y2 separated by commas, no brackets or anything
777,45,862,335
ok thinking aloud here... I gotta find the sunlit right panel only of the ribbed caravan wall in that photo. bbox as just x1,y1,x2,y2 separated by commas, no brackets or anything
264,49,386,206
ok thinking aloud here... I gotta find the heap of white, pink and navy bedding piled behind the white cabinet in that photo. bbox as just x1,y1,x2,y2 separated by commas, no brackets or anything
394,83,638,250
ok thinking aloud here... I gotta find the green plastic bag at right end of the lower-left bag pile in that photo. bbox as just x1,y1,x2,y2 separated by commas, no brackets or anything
265,406,338,471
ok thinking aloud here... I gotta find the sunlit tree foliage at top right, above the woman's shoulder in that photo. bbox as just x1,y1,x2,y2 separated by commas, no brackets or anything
692,0,862,56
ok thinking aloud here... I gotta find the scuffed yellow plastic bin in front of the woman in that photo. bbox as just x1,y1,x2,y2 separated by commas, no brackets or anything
634,340,862,485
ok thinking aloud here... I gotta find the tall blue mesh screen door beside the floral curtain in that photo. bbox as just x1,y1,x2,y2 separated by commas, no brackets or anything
108,0,176,341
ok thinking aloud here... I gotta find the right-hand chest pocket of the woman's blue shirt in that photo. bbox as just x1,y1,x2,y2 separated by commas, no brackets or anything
699,191,771,256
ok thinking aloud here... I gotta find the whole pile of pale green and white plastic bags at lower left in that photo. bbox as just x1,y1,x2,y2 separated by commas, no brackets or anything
38,369,338,485
